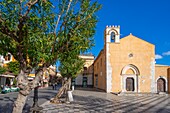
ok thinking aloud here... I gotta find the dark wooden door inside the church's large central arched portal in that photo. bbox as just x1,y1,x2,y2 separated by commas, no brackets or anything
126,77,135,91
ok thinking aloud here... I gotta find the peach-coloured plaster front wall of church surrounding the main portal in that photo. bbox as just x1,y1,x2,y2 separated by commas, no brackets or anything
107,35,155,92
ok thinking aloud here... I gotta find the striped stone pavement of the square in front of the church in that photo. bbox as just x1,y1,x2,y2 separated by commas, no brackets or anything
42,89,170,113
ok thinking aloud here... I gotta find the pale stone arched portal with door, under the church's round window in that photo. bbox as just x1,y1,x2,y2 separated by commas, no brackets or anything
121,64,140,92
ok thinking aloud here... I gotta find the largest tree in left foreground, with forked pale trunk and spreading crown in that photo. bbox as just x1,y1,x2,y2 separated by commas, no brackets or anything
0,0,101,113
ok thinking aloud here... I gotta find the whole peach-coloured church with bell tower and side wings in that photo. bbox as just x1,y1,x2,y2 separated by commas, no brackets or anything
94,26,170,93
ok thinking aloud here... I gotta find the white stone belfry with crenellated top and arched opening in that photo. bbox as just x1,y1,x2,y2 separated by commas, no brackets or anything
105,25,120,44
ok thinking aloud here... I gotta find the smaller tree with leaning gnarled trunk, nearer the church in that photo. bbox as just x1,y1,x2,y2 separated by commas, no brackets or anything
51,52,85,103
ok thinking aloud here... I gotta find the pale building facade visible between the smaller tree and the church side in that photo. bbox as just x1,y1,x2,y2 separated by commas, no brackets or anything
72,54,94,87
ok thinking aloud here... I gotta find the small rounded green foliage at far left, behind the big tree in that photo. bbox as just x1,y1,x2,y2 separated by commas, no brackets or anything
7,61,19,75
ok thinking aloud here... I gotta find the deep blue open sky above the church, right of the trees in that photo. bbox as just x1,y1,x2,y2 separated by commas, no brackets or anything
91,0,170,65
